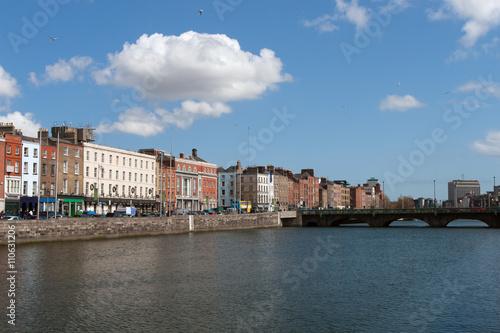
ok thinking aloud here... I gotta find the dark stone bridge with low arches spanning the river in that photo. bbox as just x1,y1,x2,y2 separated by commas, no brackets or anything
281,208,500,228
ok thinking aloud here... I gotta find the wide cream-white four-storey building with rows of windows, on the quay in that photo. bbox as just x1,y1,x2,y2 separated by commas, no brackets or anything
83,143,155,214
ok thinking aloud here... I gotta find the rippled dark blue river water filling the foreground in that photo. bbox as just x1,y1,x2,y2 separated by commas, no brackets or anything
0,219,500,332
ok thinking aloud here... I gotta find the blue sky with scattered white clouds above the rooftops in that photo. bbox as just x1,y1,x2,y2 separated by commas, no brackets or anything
0,0,500,200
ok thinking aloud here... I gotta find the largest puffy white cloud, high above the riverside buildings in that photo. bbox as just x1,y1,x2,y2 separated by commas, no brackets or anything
94,31,292,102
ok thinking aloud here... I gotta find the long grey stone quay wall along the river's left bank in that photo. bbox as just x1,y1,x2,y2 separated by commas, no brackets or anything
0,213,282,244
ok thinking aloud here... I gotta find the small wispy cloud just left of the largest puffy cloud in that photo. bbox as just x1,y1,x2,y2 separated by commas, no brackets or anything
29,56,93,86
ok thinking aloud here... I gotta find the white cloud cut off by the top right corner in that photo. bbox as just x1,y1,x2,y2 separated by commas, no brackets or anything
428,0,500,48
